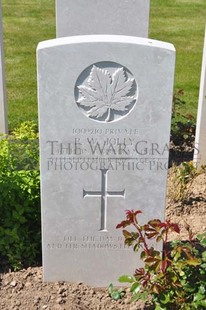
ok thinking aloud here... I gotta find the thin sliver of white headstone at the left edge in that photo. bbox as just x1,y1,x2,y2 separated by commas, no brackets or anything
0,1,8,134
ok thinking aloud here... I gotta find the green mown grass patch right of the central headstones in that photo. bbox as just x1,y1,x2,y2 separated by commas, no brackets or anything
150,0,206,116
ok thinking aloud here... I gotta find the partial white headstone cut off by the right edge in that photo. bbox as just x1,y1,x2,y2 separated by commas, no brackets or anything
194,31,206,167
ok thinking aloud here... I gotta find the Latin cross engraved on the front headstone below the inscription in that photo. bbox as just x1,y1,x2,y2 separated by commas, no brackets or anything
83,169,125,231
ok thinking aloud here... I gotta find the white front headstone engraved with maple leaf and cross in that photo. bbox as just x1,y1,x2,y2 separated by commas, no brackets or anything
37,35,175,286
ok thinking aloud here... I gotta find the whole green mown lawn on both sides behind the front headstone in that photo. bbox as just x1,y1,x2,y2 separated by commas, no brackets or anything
2,0,206,130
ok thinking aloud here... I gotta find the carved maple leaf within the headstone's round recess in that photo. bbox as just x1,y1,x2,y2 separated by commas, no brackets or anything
77,65,136,122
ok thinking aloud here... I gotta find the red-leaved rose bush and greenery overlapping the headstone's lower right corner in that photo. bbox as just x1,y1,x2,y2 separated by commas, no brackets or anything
117,210,206,310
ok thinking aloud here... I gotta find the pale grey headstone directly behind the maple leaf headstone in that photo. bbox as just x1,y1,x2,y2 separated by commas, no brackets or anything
56,0,150,38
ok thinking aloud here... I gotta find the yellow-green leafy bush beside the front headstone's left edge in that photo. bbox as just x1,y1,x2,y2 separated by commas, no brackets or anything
0,122,41,270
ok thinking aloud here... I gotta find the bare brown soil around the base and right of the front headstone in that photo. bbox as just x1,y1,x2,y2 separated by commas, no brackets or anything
0,171,206,310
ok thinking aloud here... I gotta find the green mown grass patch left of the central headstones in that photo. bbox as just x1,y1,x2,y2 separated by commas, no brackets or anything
2,0,55,130
